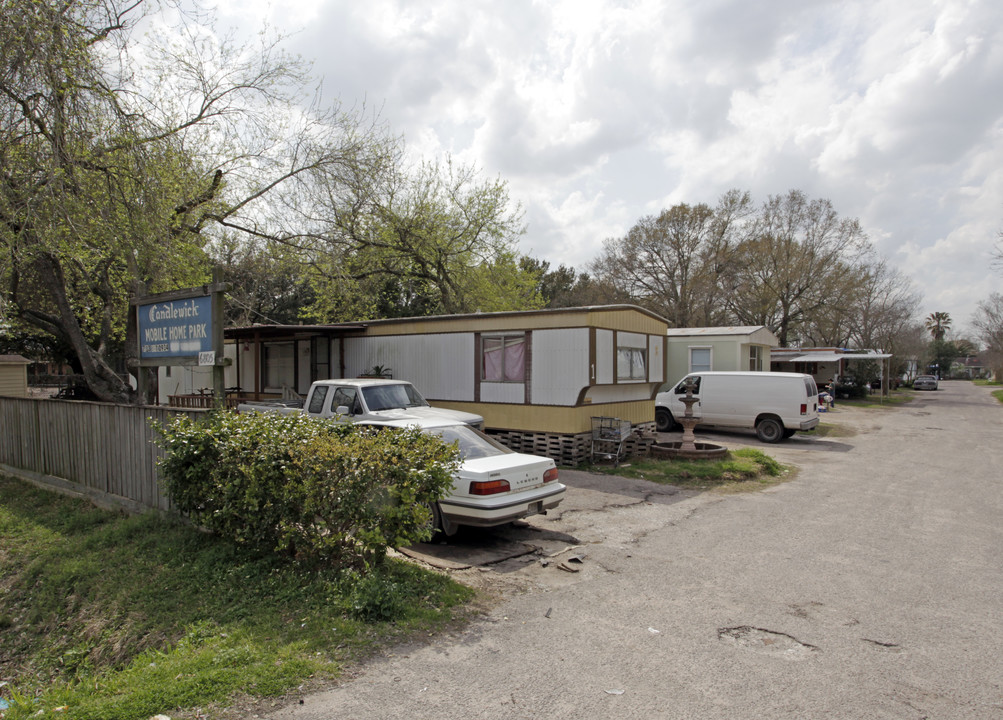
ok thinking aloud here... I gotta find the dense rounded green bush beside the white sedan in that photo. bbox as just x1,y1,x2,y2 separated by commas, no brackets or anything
159,411,459,567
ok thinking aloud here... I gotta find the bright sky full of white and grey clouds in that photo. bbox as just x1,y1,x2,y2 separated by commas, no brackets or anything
219,0,1003,330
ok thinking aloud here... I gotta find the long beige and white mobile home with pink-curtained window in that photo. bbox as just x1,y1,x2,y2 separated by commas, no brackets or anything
181,305,668,462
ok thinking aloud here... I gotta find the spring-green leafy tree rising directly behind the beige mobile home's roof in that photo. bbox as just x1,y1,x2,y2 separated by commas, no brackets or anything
296,156,540,320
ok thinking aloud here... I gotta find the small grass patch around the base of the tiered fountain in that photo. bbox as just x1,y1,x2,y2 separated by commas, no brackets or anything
593,447,790,491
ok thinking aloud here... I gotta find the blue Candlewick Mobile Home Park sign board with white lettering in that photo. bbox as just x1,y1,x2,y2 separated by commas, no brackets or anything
137,295,215,358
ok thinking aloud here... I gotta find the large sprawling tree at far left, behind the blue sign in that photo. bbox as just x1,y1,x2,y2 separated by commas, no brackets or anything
0,0,383,402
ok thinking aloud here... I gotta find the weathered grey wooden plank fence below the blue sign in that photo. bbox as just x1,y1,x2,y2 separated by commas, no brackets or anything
0,397,206,511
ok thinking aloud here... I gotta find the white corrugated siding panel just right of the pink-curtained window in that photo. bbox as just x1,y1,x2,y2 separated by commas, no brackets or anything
533,328,589,405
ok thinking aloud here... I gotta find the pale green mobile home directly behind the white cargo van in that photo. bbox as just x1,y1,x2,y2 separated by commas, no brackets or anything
666,325,780,384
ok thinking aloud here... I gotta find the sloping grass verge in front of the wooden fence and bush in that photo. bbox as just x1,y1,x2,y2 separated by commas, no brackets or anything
0,475,472,720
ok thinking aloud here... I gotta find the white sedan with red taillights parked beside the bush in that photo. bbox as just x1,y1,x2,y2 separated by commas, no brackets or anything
367,419,567,535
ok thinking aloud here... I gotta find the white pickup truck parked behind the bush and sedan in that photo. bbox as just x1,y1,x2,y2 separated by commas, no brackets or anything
237,378,484,430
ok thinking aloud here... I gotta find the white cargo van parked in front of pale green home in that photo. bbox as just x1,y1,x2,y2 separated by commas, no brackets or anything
655,372,818,442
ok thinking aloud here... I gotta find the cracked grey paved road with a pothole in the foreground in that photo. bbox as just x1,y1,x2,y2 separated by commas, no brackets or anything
267,382,1003,720
